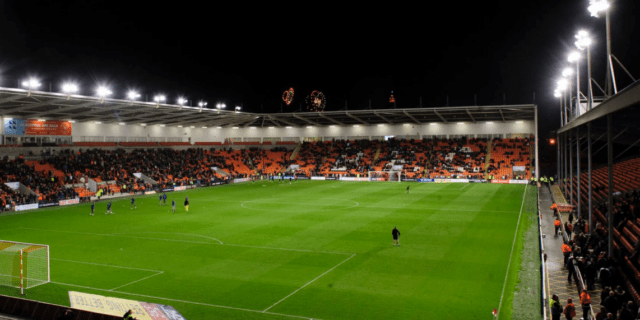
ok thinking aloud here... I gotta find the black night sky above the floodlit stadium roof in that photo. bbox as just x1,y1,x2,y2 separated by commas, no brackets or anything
0,0,640,142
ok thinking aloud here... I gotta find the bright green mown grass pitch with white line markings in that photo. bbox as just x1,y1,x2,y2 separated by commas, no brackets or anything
0,181,526,320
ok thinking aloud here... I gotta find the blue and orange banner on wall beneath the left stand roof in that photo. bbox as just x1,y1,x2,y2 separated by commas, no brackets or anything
4,119,71,136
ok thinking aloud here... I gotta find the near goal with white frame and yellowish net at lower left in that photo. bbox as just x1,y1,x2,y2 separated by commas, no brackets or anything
0,240,51,290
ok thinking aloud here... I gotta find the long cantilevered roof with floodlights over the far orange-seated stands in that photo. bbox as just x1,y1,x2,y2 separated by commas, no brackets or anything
0,88,536,127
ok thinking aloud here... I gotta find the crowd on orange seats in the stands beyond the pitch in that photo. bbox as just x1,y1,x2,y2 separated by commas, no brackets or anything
0,139,522,208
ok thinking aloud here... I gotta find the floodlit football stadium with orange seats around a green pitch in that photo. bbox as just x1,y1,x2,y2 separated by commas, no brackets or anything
0,0,640,320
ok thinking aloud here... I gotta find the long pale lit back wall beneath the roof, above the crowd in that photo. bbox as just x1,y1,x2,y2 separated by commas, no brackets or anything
66,121,535,142
